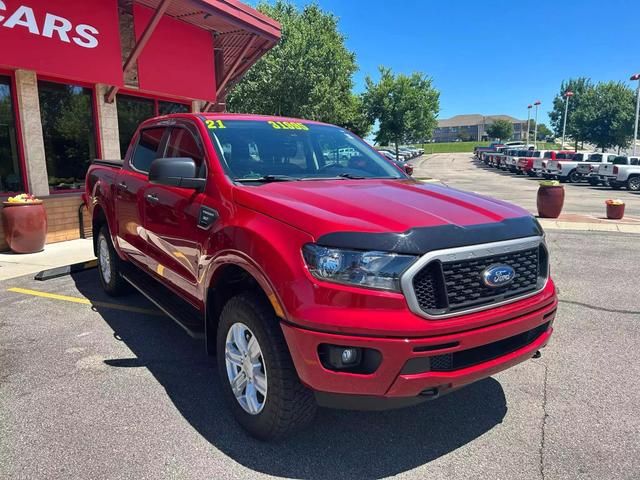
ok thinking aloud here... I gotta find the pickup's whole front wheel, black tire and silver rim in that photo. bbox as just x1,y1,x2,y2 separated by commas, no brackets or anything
217,293,317,440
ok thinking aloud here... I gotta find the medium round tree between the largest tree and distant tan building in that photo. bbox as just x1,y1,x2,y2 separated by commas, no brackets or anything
363,67,440,154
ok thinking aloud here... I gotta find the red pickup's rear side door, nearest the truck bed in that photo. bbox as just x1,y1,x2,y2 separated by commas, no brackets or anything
115,127,166,265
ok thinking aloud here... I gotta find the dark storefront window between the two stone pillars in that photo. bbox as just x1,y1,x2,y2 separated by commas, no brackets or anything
38,81,96,191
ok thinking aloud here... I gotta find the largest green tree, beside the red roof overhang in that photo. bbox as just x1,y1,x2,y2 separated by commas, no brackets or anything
228,0,371,134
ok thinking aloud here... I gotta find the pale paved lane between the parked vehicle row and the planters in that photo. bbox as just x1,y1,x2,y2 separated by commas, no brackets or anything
412,153,640,219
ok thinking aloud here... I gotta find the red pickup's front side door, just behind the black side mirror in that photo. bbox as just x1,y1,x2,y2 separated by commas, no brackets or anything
143,121,207,305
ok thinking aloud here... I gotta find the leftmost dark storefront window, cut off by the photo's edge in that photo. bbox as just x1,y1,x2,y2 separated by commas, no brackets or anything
0,76,24,194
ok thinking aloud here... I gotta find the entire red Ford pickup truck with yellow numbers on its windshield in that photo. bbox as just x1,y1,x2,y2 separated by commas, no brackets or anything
85,114,557,439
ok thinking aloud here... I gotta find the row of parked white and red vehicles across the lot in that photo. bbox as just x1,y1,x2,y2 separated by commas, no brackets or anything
474,143,640,192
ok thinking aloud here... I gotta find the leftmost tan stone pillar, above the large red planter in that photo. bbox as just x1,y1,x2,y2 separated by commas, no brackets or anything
15,70,49,197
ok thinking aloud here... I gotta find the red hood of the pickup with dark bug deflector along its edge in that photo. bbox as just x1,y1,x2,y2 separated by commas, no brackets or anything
234,179,542,253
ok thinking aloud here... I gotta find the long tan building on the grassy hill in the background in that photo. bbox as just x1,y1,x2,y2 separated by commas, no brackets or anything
433,114,527,142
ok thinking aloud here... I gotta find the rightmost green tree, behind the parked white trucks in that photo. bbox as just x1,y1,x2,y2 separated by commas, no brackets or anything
567,82,635,151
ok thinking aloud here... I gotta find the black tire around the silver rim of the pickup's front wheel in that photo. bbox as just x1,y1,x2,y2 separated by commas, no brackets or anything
217,292,317,440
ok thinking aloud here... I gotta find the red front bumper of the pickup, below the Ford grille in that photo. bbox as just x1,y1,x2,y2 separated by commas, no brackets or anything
282,295,557,403
